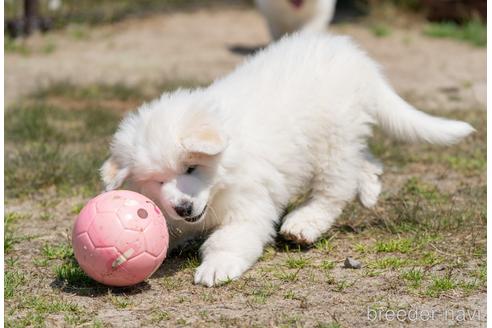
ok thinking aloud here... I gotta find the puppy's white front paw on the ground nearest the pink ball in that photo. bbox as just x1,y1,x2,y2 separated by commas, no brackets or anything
195,252,249,287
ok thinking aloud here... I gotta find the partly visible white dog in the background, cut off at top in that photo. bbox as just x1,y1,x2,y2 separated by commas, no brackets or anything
255,0,336,40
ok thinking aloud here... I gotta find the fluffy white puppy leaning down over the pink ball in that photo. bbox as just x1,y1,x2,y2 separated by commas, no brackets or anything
102,33,473,286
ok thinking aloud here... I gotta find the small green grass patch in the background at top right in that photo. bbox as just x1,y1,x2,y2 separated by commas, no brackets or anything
424,20,487,47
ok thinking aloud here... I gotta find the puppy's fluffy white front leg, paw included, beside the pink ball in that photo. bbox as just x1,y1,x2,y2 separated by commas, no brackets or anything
195,194,279,287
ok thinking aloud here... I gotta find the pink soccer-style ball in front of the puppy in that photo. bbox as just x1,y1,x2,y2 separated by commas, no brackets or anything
72,190,169,286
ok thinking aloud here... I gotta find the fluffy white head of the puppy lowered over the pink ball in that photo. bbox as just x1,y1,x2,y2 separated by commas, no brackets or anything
101,91,227,223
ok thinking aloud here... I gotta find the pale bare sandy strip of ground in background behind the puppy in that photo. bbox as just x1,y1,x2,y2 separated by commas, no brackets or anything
5,9,486,110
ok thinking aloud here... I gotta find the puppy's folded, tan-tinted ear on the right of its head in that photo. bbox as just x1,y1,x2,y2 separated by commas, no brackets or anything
181,124,227,156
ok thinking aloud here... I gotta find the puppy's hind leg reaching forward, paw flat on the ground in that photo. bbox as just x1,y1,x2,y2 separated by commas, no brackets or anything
280,144,364,244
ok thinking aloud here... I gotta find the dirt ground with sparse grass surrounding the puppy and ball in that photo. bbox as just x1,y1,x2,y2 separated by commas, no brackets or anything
4,4,486,328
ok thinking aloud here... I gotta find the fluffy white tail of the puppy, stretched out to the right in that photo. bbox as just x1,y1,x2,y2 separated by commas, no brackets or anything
368,83,475,145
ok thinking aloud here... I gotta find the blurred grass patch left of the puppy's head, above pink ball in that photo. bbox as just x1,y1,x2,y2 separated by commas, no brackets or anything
4,82,202,198
